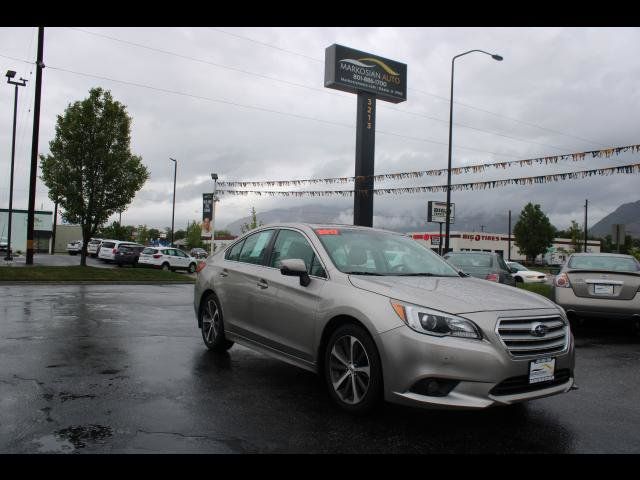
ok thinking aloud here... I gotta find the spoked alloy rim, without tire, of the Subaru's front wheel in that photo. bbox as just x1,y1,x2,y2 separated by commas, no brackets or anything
329,335,371,405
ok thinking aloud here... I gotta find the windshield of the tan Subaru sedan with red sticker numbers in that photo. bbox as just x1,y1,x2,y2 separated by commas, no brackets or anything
315,227,459,277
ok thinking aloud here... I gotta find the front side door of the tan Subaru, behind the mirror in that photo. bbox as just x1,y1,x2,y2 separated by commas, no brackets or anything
244,229,327,362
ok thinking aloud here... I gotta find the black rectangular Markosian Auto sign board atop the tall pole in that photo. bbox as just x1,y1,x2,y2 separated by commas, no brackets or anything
324,44,407,103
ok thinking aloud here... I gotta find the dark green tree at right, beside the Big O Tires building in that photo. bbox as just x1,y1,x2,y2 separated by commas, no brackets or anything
513,202,556,262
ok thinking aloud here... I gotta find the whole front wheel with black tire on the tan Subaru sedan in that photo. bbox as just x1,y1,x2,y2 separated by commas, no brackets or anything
323,324,382,415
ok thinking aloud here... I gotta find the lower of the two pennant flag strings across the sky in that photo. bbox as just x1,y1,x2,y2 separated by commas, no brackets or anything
217,163,640,197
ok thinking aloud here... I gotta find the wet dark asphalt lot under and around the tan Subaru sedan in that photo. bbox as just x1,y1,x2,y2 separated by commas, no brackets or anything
0,285,640,453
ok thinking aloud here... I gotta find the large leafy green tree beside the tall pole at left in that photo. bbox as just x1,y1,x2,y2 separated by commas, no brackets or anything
40,88,149,266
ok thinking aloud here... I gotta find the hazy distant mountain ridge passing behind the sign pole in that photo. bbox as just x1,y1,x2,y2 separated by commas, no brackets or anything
223,204,518,235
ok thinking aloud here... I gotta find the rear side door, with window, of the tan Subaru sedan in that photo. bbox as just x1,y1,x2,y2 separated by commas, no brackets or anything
214,229,275,341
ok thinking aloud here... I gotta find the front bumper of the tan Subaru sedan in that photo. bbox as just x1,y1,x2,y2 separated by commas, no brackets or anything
379,312,574,409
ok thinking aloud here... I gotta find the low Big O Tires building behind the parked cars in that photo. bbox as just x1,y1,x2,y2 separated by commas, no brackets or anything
409,232,600,264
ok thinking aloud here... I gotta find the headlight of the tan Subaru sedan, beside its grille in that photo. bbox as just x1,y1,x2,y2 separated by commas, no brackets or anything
390,300,482,339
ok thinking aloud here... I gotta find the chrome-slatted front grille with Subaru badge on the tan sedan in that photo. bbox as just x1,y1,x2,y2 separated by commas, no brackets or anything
496,315,569,357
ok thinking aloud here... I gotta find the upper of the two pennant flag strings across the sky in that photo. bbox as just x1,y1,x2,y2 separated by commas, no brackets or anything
218,145,640,188
